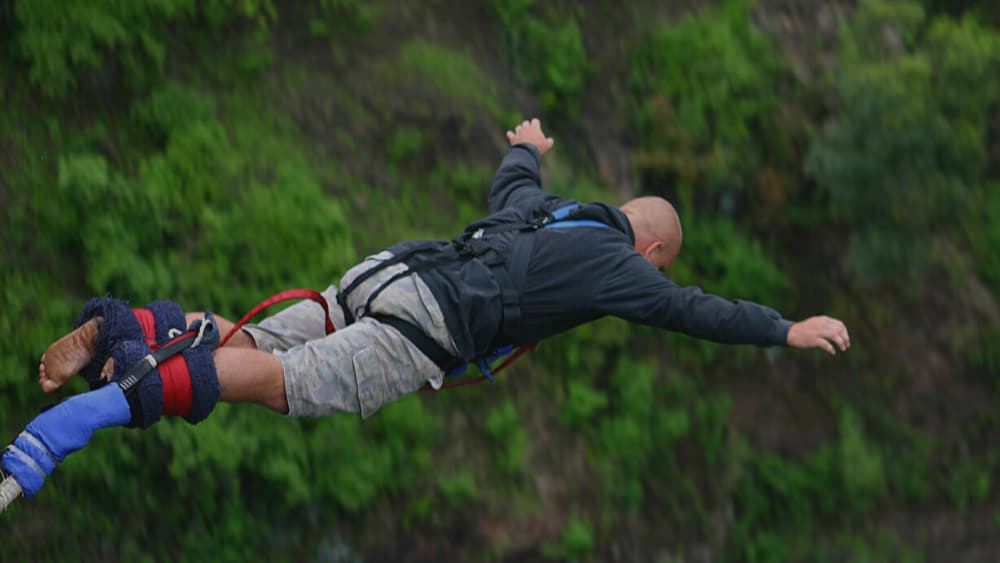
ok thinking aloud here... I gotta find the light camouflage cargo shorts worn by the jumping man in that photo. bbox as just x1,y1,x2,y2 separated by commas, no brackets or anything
245,252,457,418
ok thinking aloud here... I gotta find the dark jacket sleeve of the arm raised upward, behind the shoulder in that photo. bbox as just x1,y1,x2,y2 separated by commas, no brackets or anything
489,143,555,213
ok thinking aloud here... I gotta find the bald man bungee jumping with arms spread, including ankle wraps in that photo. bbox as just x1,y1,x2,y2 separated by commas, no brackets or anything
3,119,850,498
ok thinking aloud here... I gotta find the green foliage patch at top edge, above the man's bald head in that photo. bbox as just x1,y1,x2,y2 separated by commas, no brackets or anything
630,0,781,208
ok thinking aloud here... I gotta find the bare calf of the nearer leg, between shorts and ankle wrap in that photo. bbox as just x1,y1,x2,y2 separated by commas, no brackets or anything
215,348,288,414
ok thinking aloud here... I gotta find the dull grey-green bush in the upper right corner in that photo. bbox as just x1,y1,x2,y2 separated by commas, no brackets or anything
807,0,1000,286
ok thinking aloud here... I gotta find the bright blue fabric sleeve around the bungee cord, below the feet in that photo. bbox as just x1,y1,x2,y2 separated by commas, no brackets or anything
0,385,131,498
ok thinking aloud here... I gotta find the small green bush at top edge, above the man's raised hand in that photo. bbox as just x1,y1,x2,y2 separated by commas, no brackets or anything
491,0,591,119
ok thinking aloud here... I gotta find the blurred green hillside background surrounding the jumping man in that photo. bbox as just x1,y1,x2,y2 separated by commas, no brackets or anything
0,0,1000,563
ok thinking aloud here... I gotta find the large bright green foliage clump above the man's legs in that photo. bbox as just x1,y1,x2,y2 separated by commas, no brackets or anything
46,86,360,312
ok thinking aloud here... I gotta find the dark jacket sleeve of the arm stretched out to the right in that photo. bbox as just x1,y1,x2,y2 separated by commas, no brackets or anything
593,253,792,346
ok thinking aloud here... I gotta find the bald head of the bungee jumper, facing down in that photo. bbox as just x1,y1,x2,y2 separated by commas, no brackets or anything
621,196,684,269
